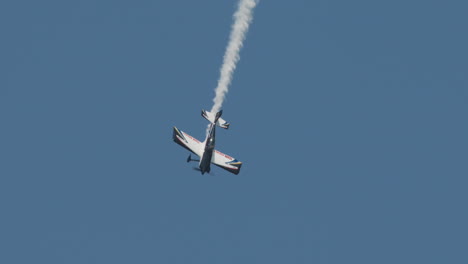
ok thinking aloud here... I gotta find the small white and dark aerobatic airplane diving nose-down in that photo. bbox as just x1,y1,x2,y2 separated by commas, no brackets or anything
172,110,242,174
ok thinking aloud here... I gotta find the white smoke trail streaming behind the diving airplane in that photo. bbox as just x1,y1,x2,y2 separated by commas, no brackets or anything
211,0,258,113
